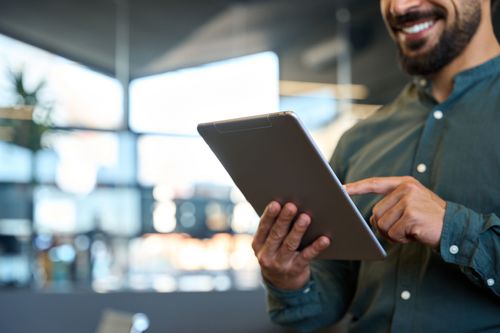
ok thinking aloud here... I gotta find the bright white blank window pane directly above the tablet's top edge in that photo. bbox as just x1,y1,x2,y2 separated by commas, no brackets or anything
130,52,279,135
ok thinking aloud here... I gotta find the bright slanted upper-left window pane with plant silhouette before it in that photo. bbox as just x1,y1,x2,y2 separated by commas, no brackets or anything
0,35,123,129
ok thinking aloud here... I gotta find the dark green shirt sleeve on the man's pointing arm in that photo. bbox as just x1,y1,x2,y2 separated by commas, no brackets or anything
440,202,500,297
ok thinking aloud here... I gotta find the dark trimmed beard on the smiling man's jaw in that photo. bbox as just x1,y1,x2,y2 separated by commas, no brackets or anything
398,0,482,76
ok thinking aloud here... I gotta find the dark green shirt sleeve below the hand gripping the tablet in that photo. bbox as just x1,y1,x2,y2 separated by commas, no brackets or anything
265,260,358,332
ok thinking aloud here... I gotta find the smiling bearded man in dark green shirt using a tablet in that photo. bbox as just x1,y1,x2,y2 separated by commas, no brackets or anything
253,0,500,332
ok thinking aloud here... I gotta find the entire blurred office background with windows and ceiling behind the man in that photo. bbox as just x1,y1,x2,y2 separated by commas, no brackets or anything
0,0,500,332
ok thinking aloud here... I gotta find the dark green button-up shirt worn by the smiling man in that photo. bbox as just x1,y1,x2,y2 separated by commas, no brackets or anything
268,57,500,333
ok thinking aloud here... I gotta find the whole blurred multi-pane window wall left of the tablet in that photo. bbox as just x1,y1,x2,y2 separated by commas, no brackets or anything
0,36,279,292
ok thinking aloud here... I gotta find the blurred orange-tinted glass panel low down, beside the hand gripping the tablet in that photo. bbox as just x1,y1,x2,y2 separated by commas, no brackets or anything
129,233,261,292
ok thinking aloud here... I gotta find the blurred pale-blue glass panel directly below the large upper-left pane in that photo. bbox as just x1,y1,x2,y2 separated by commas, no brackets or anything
36,131,134,189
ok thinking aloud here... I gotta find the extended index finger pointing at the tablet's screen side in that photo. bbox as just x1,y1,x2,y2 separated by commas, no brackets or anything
344,176,413,195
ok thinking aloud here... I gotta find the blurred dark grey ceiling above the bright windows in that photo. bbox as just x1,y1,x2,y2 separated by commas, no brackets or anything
0,0,500,103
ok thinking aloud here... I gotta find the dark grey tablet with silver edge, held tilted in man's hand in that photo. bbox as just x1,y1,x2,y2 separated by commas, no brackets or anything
198,112,386,260
